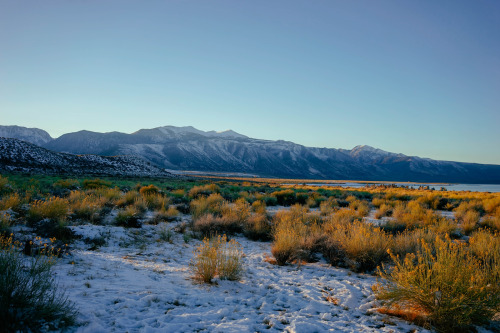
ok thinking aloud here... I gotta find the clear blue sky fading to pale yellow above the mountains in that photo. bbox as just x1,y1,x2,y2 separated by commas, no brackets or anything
0,0,500,164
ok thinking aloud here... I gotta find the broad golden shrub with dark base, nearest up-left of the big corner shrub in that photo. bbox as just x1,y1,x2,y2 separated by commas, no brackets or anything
323,221,392,272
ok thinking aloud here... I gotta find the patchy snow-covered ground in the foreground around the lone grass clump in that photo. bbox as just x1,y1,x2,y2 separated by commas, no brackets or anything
51,218,434,332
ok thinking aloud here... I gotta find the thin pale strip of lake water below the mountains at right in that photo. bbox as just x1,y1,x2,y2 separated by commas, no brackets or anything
292,182,500,192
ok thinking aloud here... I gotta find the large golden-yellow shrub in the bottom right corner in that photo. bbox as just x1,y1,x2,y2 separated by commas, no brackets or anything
375,238,500,332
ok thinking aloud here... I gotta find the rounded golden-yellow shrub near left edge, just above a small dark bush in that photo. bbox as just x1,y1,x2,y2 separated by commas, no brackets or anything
28,197,70,223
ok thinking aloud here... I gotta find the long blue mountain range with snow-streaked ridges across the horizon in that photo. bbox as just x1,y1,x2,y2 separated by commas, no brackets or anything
0,126,500,184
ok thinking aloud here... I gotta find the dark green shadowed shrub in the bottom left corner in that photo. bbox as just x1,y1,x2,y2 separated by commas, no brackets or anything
0,235,76,332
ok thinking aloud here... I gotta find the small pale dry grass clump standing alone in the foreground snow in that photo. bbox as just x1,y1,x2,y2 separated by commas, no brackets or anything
191,235,243,283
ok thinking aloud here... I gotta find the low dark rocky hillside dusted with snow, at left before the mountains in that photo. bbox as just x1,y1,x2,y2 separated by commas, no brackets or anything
0,137,172,177
